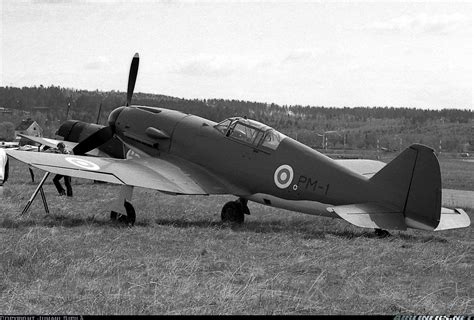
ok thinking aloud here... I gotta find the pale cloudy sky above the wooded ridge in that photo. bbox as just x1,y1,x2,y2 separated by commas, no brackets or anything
0,0,474,109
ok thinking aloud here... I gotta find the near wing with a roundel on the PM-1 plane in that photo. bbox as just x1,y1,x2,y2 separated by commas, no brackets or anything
7,150,239,195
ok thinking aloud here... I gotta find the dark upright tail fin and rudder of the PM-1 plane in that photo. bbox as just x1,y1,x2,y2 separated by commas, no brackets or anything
370,144,441,230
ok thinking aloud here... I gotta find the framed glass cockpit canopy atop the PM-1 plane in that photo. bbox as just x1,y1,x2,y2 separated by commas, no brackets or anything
215,117,285,150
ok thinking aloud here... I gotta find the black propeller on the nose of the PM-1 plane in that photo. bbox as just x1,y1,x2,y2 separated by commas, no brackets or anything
72,53,140,155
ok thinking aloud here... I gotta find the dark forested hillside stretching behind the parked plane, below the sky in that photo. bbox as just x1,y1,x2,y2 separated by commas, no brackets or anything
0,86,474,152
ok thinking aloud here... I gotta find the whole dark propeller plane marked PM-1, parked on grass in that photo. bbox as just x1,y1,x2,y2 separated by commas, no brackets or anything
7,53,470,235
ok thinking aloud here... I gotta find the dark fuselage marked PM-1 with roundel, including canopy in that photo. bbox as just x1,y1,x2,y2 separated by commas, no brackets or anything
113,106,379,216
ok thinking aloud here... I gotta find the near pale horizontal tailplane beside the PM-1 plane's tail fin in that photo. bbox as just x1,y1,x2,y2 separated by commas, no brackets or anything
327,203,407,230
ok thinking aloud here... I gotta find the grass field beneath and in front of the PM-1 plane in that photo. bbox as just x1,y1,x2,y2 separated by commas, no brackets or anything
0,160,474,314
